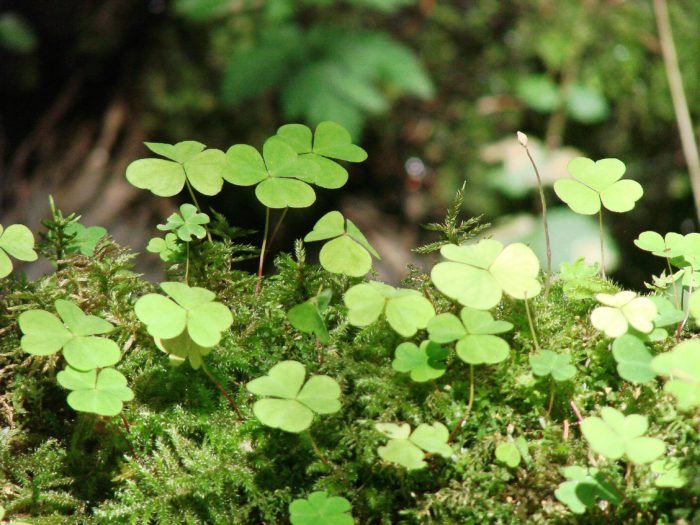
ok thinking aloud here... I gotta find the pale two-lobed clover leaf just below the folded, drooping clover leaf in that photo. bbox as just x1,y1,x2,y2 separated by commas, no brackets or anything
345,281,435,337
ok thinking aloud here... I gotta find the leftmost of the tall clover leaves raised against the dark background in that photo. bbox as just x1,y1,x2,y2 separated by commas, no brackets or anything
126,141,226,197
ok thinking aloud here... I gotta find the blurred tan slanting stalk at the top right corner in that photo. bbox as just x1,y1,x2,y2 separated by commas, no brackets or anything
654,0,700,221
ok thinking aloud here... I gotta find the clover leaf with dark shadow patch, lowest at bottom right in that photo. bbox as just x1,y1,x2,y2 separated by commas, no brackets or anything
554,466,622,514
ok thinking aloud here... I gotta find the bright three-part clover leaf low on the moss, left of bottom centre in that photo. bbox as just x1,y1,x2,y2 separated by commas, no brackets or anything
247,361,340,433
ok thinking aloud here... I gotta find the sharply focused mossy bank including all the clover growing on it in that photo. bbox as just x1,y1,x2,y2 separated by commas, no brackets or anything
0,122,700,525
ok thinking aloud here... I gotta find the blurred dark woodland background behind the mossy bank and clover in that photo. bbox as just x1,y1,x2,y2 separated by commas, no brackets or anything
0,0,700,288
